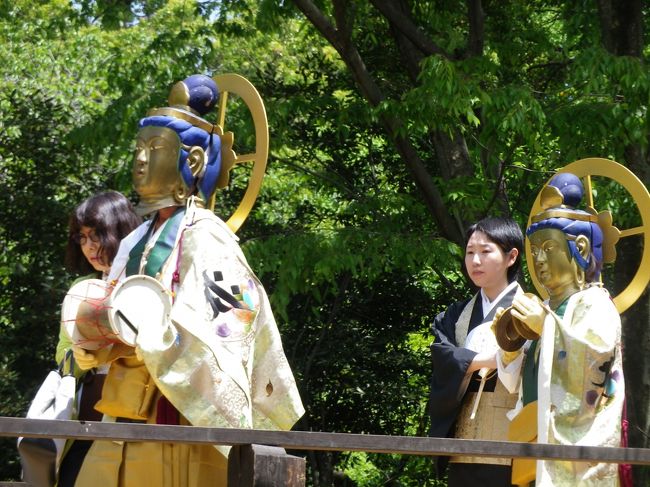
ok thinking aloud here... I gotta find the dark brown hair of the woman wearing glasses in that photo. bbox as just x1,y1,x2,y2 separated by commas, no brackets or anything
65,191,142,274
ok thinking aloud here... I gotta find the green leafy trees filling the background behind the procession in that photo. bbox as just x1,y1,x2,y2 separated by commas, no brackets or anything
0,0,650,486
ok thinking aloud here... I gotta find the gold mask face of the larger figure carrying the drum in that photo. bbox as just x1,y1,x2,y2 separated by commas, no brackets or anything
132,126,181,202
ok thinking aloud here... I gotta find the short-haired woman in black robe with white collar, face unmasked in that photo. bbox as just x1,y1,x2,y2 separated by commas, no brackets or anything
430,218,524,487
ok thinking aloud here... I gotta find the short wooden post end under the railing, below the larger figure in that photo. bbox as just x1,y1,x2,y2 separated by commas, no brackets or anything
228,445,305,487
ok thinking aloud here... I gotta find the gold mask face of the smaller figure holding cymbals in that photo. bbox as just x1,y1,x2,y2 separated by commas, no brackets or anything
529,228,578,298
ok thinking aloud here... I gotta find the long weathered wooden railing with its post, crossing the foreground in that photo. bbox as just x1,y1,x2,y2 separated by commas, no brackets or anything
0,417,650,487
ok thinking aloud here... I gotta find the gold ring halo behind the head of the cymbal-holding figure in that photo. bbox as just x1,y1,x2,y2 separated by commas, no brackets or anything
525,157,650,313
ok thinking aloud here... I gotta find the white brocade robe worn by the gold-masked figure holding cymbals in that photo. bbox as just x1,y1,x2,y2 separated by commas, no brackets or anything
499,285,625,487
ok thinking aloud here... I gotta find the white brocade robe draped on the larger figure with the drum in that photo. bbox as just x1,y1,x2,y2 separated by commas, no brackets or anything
112,200,304,436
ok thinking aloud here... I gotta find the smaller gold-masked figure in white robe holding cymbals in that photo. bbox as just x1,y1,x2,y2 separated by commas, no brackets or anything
497,173,625,486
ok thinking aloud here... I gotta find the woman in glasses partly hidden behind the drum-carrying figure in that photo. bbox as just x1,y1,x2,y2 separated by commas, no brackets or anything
56,191,142,487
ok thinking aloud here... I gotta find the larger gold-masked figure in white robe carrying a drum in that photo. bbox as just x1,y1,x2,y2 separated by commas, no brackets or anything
76,75,304,487
